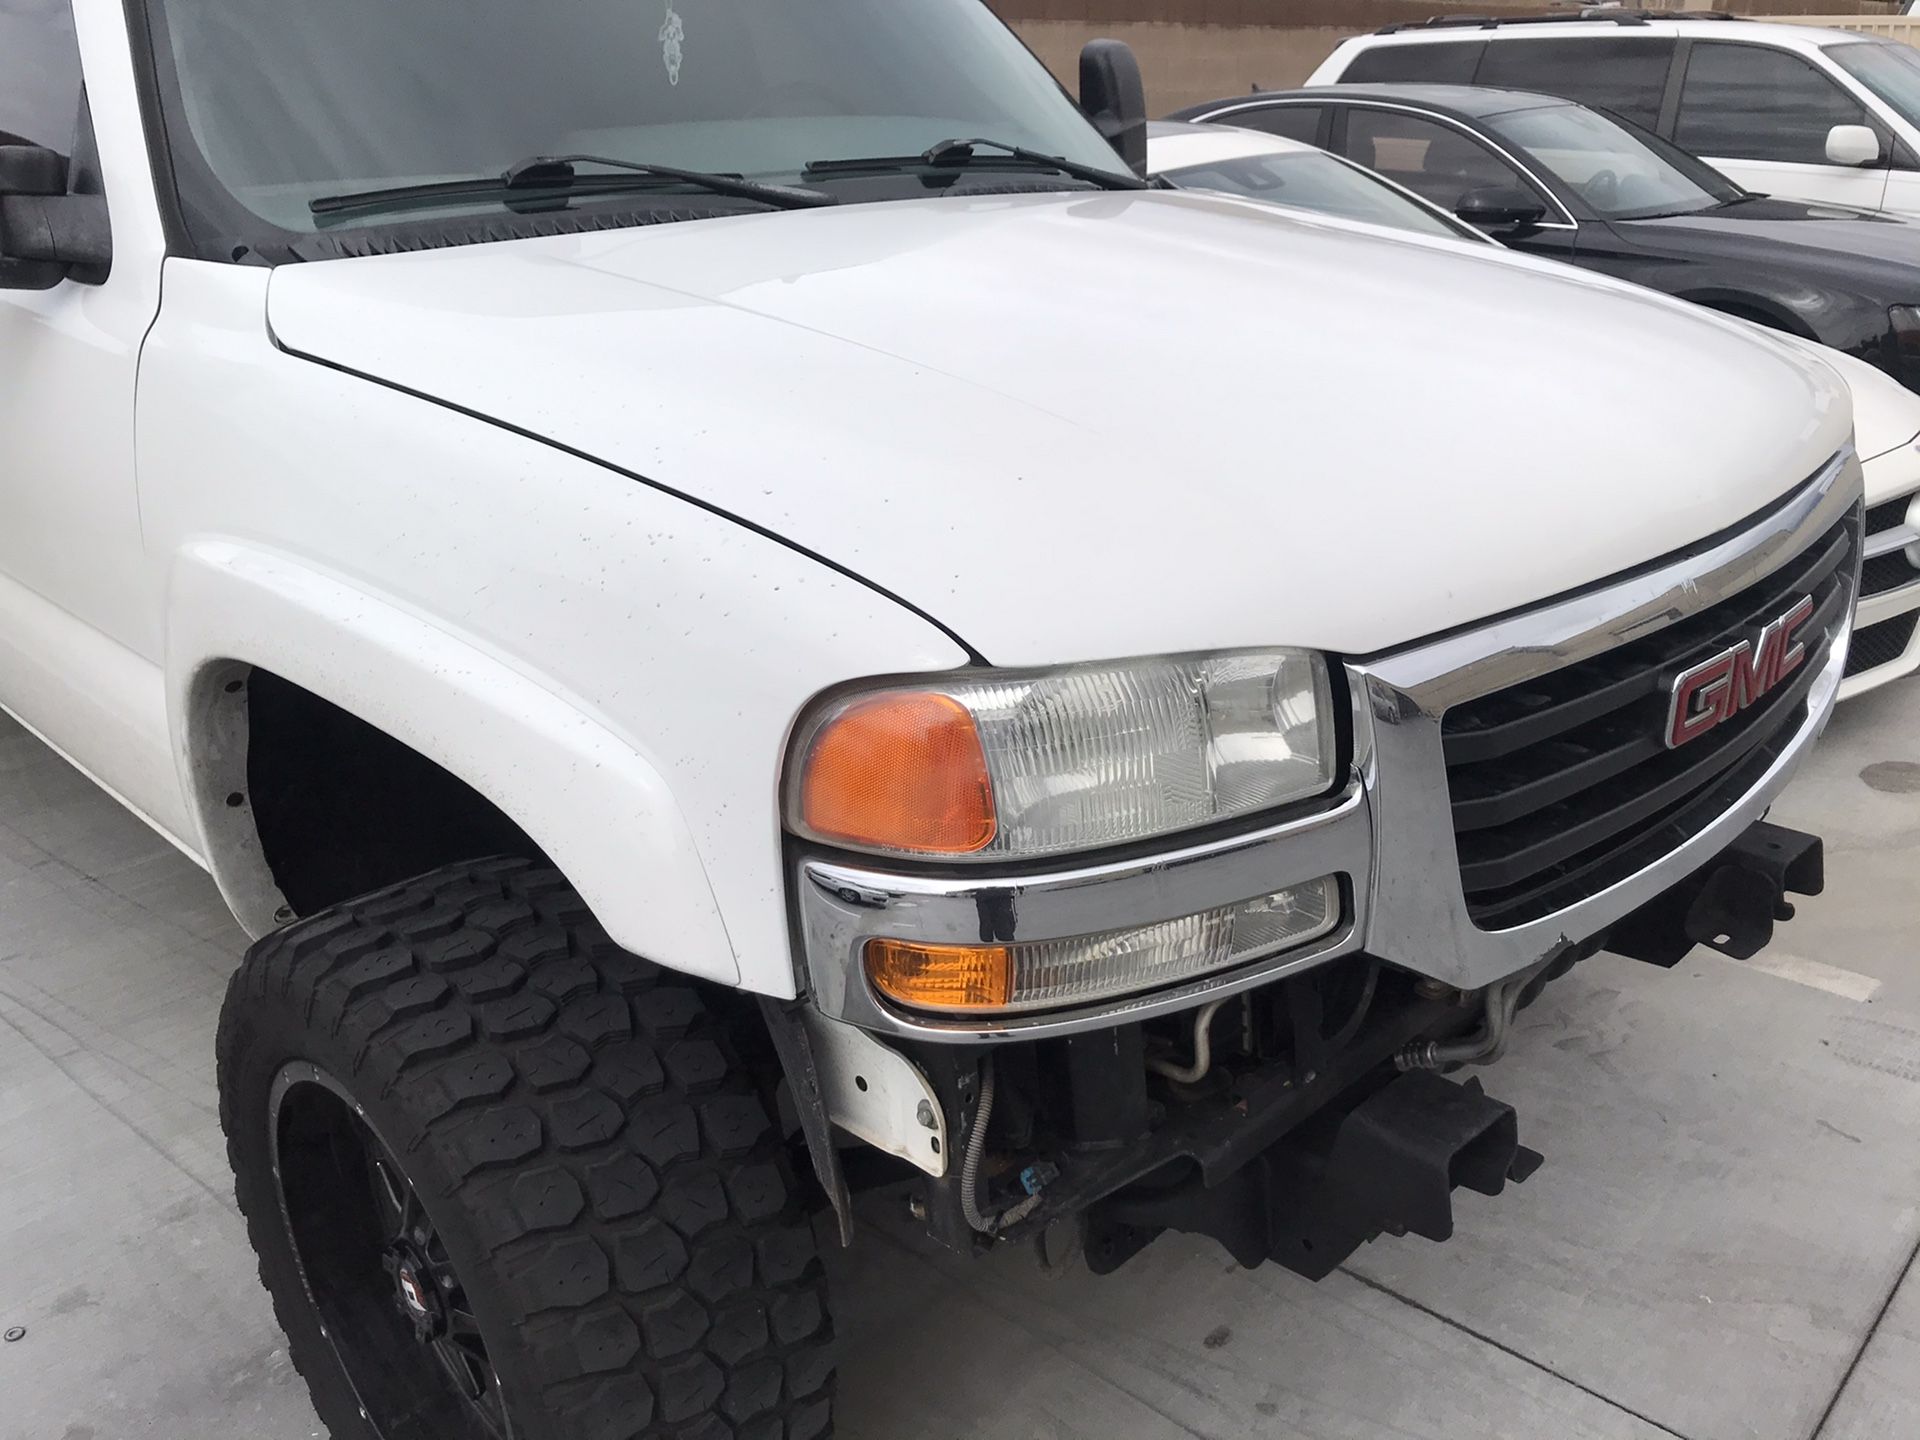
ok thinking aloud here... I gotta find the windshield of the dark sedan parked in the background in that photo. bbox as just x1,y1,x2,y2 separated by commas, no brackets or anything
1486,106,1745,221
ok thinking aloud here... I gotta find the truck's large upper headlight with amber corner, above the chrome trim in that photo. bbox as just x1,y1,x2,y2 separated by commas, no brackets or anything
787,649,1334,860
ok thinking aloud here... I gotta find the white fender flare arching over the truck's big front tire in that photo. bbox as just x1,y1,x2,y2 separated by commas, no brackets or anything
167,538,739,985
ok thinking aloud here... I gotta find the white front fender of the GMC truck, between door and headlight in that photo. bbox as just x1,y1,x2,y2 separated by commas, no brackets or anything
138,259,966,995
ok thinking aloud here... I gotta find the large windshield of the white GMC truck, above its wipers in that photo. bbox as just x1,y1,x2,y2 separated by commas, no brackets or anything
148,0,1125,257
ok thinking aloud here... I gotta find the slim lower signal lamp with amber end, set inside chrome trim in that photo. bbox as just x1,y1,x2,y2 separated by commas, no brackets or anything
866,877,1340,1016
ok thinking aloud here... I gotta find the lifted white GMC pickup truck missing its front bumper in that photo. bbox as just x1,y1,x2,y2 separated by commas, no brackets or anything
0,0,1862,1440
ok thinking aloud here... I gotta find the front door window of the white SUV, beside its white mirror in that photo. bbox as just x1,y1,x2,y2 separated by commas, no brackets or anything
1674,40,1880,165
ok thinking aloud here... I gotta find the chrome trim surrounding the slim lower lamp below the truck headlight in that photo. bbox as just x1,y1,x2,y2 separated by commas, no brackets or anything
793,783,1373,1041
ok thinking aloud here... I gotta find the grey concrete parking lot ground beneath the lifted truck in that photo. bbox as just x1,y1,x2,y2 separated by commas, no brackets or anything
0,685,1920,1440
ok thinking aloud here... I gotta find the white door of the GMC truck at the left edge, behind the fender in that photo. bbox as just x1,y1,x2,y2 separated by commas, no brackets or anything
0,0,184,835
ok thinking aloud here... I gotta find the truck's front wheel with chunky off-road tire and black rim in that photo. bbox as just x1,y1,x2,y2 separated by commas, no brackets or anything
219,860,833,1440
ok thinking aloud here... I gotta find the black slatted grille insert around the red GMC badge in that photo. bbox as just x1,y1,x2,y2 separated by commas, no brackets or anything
1442,511,1860,929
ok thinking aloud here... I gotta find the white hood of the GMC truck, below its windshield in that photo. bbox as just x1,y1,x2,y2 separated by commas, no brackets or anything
267,192,1851,664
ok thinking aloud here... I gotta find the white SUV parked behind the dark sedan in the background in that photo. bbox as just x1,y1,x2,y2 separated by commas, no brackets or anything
1308,12,1920,215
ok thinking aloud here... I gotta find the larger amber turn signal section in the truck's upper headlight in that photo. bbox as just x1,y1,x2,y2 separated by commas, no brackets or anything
801,689,995,854
